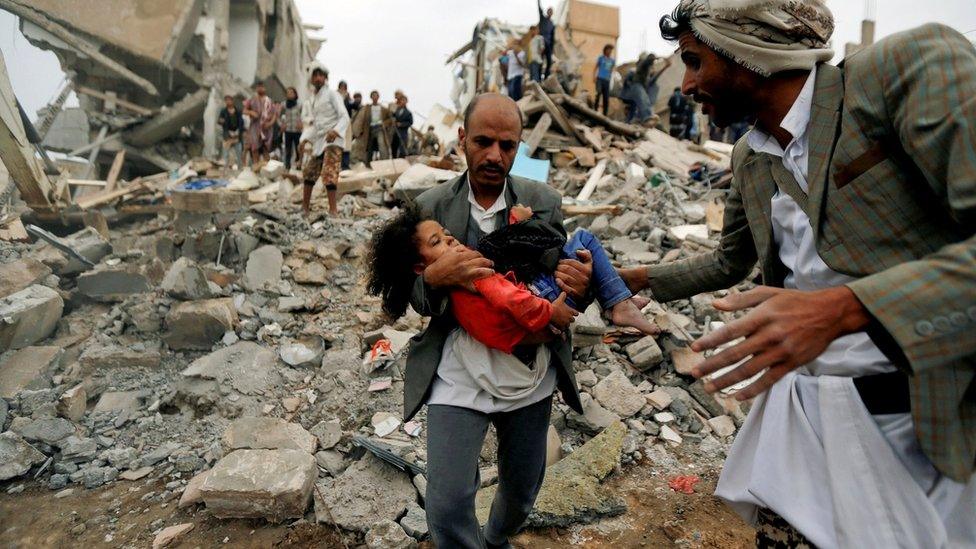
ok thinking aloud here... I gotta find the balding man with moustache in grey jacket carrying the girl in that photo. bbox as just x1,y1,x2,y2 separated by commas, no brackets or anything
404,94,591,549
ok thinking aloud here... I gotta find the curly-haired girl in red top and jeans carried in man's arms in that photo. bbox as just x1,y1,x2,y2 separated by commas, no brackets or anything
367,200,659,353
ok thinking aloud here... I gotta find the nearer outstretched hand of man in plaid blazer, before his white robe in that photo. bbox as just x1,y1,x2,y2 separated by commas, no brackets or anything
691,286,870,400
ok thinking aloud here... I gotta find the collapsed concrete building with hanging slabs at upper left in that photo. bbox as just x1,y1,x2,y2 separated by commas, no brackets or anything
0,0,322,217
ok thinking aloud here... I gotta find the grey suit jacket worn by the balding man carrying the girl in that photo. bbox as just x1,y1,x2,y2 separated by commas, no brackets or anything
403,174,583,421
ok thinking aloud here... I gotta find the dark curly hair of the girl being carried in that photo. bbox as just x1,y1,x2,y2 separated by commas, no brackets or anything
366,203,429,319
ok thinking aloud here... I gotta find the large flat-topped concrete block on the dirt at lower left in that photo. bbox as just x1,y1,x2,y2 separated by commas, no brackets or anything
200,449,318,523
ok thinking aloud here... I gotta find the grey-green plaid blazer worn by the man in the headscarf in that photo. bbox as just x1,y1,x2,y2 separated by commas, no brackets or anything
648,24,976,481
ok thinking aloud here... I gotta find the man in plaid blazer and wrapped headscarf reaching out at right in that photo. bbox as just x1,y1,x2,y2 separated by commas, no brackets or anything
621,0,976,547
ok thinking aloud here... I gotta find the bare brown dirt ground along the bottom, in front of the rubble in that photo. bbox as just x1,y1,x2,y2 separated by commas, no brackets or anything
0,446,753,549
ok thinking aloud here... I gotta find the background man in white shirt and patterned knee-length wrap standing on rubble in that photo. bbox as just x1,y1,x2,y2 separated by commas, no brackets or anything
300,67,349,215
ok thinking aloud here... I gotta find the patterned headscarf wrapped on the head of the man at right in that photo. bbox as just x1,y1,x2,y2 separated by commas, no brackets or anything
680,0,834,76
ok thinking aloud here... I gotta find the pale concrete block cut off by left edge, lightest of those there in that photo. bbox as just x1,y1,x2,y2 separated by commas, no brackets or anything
0,284,64,352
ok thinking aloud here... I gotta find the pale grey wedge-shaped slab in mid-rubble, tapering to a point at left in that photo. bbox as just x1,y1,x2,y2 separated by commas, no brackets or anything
182,341,281,395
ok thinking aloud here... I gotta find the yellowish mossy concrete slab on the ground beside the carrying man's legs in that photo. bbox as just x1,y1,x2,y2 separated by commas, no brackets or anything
475,421,627,528
